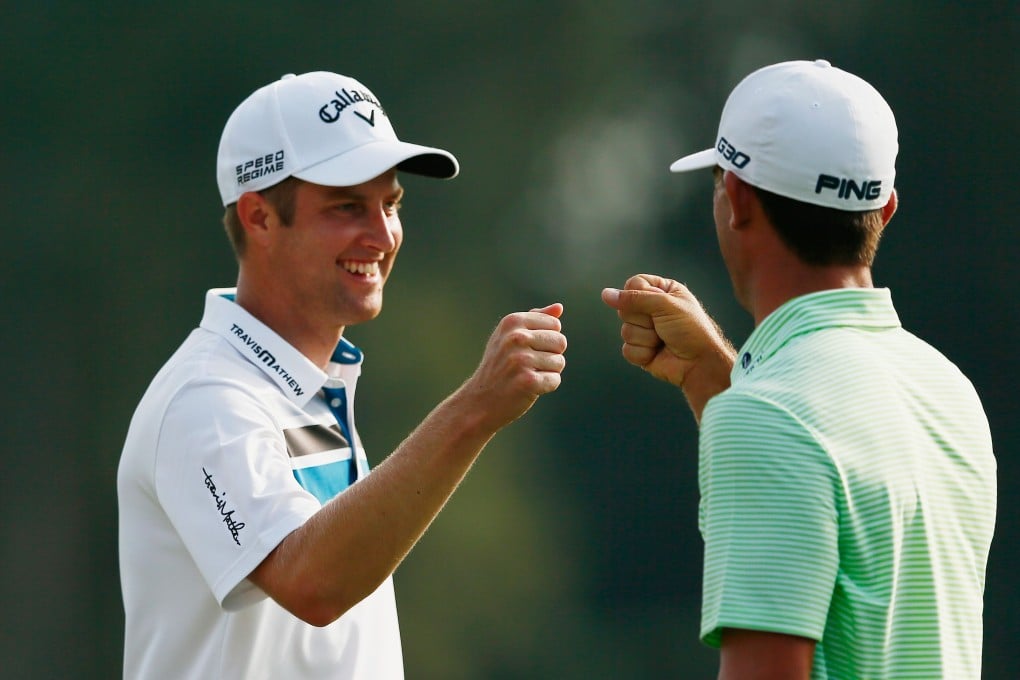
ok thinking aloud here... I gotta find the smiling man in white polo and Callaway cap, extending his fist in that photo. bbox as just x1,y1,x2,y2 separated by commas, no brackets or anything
117,72,566,680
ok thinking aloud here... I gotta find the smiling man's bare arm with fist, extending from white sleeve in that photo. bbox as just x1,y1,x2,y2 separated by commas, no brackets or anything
250,304,567,625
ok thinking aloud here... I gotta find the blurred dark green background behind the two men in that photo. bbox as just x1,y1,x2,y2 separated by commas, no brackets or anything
0,0,1020,680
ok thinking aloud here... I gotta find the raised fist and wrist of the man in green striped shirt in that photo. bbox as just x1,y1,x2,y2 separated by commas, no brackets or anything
602,274,736,422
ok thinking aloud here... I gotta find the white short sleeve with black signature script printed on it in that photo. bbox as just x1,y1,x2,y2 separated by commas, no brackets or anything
154,381,321,610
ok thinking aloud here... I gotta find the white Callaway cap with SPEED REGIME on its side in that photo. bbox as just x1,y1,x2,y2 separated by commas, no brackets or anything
216,71,460,206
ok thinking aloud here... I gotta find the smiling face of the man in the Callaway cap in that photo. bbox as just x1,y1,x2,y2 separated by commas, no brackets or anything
266,170,404,327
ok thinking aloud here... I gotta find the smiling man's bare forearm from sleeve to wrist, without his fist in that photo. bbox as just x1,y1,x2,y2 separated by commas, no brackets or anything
256,387,498,625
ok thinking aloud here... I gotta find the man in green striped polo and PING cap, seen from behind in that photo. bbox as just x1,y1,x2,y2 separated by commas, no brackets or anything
603,60,996,680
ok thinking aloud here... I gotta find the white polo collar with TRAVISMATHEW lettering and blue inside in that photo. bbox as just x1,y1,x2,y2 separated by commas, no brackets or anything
200,287,362,407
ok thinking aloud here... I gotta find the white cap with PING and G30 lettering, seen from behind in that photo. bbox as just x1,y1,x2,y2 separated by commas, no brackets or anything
669,59,899,211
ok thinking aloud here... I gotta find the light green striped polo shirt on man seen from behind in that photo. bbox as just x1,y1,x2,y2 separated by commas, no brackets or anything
699,289,996,680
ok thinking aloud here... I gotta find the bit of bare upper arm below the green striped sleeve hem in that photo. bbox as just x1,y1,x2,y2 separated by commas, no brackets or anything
719,628,815,680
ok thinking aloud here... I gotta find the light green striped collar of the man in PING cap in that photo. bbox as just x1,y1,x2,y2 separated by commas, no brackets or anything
730,289,901,382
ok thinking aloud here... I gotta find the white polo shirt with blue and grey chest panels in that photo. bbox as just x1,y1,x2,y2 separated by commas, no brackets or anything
117,289,403,680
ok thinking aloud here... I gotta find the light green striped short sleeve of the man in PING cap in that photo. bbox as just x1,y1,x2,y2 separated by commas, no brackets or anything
699,393,839,647
